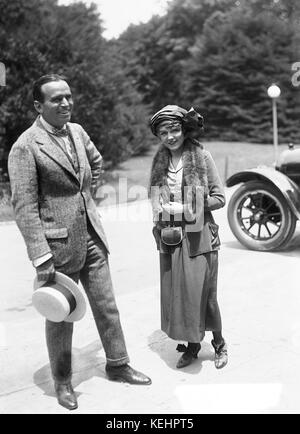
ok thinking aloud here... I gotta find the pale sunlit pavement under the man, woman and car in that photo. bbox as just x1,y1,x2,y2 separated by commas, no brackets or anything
0,191,300,414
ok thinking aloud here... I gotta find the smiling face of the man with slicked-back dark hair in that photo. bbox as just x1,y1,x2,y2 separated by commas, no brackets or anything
34,80,73,128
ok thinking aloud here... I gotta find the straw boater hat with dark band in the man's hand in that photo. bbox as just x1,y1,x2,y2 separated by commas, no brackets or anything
32,271,86,322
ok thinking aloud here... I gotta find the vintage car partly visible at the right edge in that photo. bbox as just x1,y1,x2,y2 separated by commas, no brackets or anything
226,144,300,251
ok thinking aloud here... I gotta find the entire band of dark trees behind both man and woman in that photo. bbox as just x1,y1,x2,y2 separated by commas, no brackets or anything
0,0,300,181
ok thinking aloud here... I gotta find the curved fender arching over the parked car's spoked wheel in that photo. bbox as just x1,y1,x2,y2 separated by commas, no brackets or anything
226,166,300,219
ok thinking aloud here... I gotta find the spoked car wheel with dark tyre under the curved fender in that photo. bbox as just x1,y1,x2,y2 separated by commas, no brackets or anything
227,181,297,251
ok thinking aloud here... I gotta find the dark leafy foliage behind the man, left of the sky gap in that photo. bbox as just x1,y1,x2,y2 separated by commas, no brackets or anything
0,0,147,178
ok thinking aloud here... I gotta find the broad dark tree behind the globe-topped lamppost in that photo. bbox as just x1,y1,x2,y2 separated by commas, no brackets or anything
185,1,299,142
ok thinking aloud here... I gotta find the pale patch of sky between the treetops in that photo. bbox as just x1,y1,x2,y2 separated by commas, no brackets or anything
59,0,168,39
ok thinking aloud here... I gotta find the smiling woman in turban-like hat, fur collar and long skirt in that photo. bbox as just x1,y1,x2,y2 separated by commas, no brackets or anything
150,105,228,369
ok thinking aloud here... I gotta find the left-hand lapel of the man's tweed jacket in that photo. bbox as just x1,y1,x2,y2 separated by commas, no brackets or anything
34,119,78,182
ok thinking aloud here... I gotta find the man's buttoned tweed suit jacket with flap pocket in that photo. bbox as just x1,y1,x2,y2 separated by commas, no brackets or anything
8,117,108,274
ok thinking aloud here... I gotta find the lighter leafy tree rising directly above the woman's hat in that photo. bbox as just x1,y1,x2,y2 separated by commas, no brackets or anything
118,0,240,111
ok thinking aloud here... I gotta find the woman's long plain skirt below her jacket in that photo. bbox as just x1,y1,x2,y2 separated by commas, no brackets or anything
160,239,222,342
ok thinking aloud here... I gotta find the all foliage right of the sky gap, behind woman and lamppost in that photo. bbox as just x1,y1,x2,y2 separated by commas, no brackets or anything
119,0,300,143
